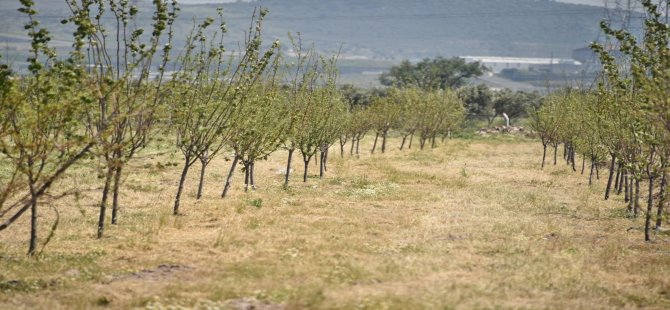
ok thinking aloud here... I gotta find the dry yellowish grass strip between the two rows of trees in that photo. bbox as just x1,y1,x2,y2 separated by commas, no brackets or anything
0,138,670,309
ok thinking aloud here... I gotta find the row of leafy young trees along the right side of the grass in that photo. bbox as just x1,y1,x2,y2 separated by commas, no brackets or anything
531,0,670,241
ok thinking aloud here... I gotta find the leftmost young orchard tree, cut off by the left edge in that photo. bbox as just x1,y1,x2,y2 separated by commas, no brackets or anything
0,0,93,256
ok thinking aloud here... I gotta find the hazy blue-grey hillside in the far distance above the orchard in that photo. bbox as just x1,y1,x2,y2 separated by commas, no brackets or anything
0,0,603,59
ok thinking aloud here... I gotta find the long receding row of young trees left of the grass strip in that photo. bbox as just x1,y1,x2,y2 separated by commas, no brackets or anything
0,0,465,255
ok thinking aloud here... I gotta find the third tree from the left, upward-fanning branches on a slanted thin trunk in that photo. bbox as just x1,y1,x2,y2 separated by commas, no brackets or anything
169,9,279,215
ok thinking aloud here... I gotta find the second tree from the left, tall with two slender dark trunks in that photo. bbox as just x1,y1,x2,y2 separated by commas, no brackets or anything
63,0,178,238
